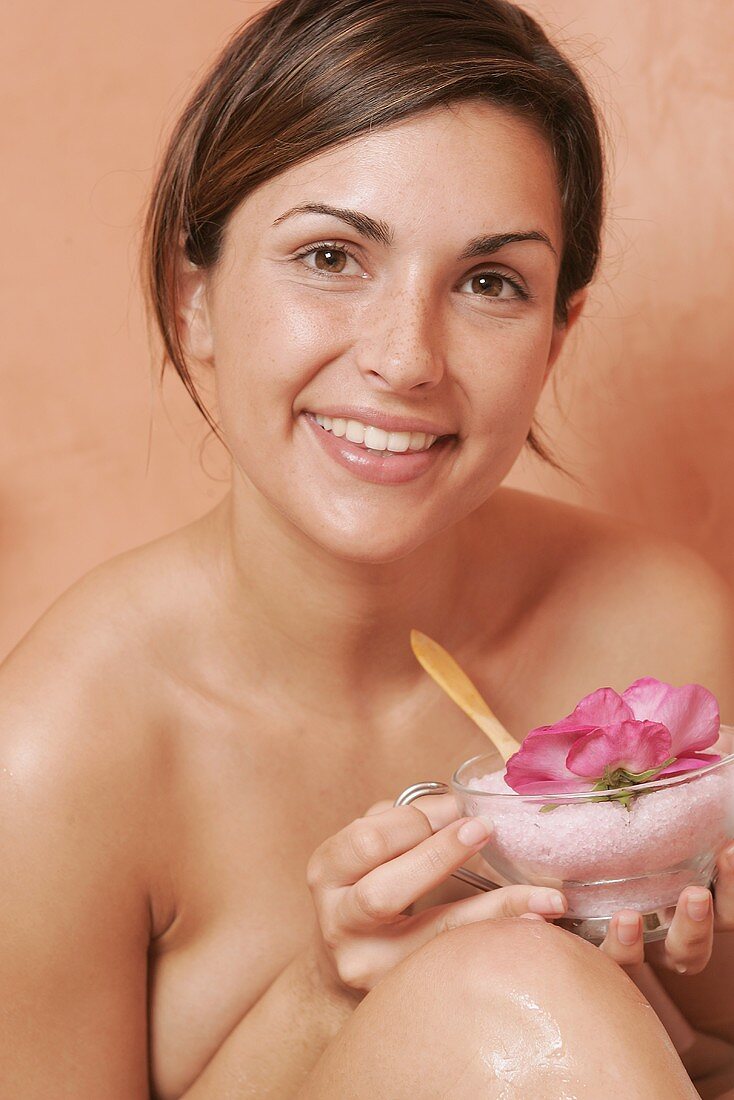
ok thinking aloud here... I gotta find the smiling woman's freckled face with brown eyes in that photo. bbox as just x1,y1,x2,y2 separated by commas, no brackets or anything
185,102,581,562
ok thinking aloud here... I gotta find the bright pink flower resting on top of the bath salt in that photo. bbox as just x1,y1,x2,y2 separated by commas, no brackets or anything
505,677,721,794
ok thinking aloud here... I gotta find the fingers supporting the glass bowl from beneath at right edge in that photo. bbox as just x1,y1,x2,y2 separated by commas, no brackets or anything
601,844,734,977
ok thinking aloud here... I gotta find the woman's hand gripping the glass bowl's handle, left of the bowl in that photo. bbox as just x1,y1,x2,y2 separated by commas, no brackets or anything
306,794,567,993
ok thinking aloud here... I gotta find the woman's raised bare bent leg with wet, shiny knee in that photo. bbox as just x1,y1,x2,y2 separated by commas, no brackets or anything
298,919,698,1100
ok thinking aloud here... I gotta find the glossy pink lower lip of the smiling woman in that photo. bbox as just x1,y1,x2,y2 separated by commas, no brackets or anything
298,413,454,485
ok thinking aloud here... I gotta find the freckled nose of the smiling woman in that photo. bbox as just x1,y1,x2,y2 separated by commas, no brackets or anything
359,289,445,393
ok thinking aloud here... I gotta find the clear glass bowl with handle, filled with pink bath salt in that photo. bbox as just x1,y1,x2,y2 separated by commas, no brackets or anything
451,726,734,943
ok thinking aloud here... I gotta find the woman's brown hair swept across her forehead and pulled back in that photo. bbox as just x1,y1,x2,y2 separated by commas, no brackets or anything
143,0,604,469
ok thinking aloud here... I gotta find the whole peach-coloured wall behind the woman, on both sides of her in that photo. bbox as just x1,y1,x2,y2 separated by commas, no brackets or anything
0,0,734,655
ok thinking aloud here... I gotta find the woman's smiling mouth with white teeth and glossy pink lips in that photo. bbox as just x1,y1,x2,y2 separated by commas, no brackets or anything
300,410,457,485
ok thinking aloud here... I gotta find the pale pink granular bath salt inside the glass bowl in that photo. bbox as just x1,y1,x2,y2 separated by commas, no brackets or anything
470,770,734,917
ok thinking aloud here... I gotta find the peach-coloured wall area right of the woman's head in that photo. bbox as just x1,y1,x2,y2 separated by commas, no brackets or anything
513,0,734,582
